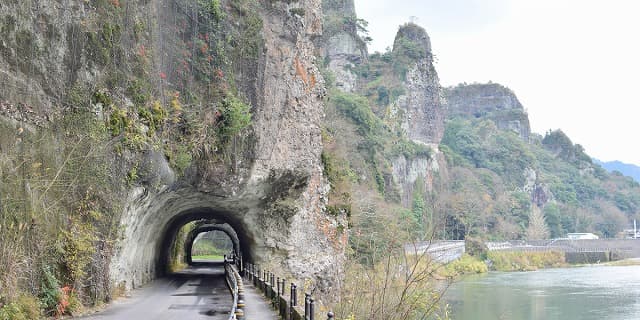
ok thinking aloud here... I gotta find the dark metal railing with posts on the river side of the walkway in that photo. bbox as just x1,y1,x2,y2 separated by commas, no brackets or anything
244,263,334,320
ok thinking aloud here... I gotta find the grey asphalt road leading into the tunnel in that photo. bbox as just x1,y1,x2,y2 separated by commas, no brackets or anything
81,262,233,320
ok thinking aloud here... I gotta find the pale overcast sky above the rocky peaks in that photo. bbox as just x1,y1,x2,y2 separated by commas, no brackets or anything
355,0,640,165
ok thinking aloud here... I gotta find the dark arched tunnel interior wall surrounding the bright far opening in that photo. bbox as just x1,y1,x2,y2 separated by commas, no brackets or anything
156,208,252,276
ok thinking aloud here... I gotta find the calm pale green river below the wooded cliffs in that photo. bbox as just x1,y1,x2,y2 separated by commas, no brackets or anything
444,266,640,320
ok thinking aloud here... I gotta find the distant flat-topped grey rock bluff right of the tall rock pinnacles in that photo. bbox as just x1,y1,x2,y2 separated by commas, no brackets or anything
445,83,531,141
